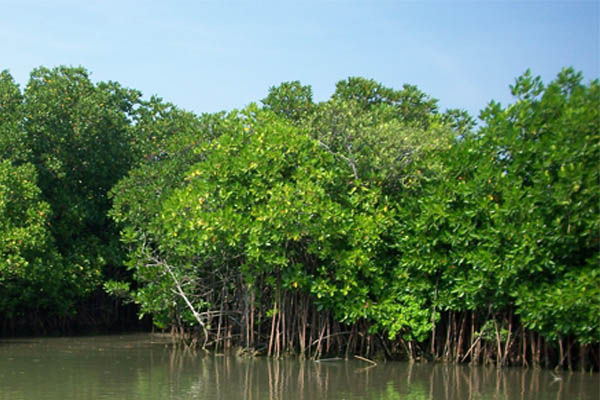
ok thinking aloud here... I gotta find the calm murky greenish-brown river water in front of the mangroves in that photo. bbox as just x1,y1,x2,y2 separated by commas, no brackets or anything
0,334,600,400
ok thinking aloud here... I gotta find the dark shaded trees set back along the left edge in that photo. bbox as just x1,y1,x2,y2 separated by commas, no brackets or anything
0,67,157,334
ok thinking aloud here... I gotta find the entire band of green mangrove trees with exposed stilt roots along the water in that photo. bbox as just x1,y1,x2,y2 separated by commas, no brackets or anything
0,67,600,369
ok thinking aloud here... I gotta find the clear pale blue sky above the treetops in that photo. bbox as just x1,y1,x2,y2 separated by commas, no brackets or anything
0,0,600,119
